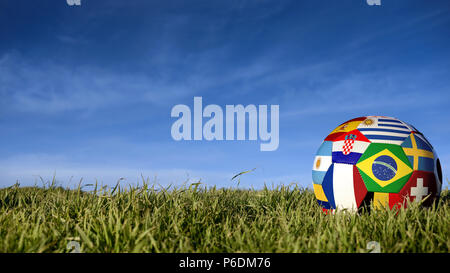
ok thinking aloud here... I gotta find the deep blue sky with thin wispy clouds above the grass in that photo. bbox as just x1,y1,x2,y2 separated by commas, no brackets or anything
0,0,450,188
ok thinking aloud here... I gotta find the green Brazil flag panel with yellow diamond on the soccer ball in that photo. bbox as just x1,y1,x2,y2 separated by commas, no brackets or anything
356,143,413,193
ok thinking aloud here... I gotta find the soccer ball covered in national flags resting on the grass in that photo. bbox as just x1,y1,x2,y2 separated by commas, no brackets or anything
312,116,442,211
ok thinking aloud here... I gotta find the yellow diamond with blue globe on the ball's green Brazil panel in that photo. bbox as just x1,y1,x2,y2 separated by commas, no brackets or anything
356,149,412,187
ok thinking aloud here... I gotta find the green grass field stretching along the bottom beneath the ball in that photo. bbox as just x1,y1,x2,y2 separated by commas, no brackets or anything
0,180,450,252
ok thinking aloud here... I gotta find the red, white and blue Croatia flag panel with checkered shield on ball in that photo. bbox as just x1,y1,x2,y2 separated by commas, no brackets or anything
332,130,370,165
